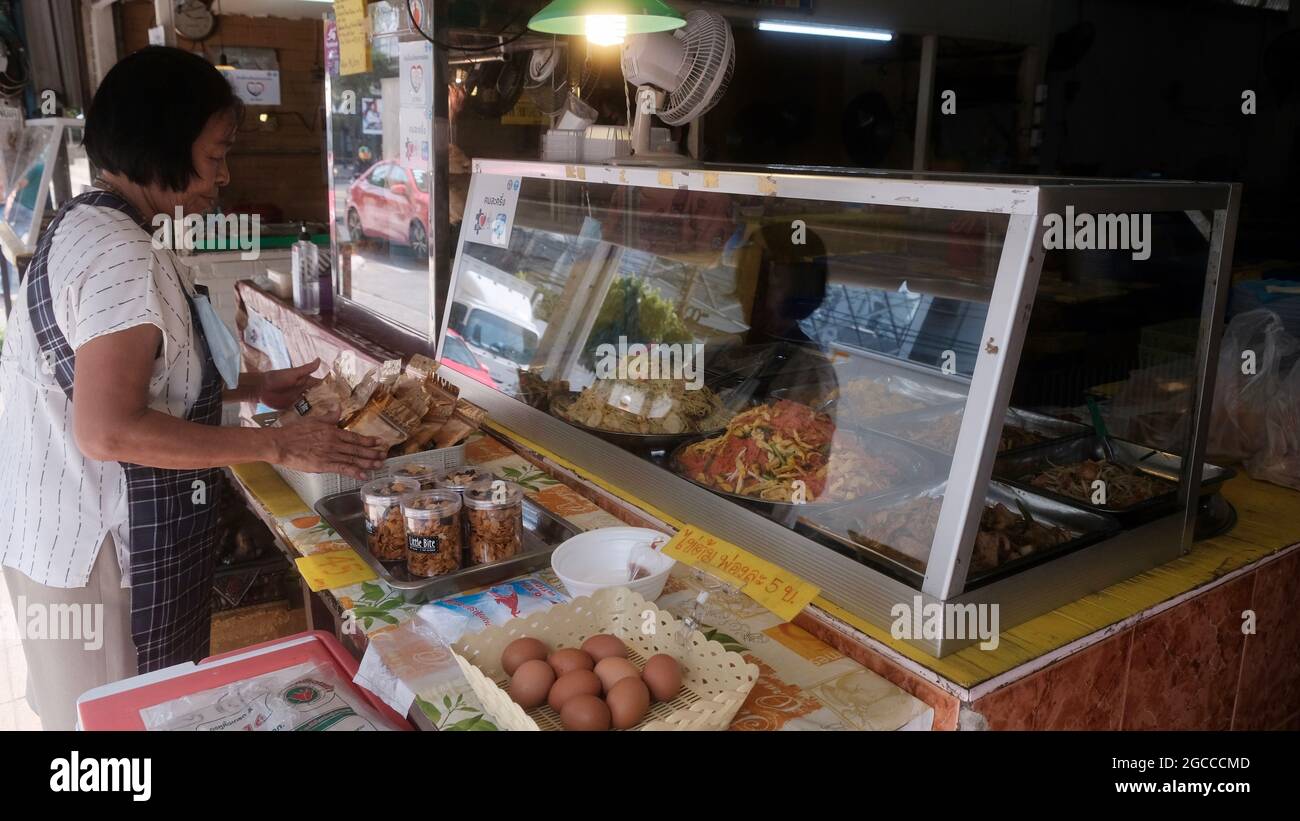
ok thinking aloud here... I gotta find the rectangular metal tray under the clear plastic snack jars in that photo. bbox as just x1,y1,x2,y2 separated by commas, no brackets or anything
316,490,579,603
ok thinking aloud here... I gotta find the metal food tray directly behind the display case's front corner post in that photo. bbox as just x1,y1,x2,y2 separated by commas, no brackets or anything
796,482,1119,590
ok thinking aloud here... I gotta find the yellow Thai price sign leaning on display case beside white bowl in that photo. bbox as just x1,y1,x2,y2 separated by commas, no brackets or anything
663,525,822,621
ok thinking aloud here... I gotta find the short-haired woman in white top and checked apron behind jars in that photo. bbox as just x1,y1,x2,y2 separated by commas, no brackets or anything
0,48,382,730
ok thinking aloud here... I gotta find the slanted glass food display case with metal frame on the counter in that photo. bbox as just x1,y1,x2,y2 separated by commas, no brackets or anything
439,160,1238,655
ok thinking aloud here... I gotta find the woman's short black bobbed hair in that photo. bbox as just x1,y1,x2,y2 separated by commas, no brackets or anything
85,45,243,191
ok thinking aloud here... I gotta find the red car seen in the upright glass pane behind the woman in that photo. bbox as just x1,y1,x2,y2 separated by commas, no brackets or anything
347,160,429,257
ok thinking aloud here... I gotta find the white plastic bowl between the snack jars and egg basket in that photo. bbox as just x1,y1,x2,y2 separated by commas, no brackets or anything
551,527,676,601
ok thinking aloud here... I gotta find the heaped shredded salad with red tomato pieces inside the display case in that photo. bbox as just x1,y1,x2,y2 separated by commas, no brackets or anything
676,399,902,503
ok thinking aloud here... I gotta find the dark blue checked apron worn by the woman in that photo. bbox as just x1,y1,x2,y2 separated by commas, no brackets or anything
27,191,225,673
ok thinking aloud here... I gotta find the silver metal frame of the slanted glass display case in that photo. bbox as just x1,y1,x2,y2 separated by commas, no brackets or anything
438,160,1240,656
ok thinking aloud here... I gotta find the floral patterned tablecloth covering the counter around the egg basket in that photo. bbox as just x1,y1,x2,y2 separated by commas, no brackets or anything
228,434,932,730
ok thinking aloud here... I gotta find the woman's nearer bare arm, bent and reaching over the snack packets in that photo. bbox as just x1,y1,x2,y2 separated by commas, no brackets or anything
73,325,384,478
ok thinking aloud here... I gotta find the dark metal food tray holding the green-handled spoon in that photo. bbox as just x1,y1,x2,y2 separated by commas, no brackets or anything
993,434,1236,527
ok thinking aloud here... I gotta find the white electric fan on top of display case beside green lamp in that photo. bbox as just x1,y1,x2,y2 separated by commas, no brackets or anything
623,10,736,164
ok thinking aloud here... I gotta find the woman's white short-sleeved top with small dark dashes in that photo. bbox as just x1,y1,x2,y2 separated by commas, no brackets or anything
0,205,203,587
